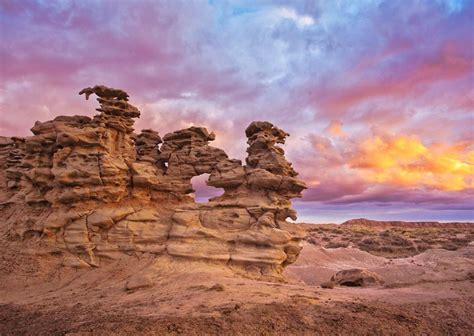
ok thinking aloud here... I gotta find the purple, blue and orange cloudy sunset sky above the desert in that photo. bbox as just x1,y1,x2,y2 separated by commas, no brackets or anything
0,0,474,223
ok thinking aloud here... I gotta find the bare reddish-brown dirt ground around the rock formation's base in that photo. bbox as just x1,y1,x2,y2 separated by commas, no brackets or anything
0,225,474,335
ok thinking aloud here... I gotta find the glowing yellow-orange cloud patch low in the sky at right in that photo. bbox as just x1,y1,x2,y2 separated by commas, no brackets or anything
349,135,474,191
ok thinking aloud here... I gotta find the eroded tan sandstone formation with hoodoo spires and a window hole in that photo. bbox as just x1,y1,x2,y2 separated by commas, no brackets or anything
0,86,306,275
